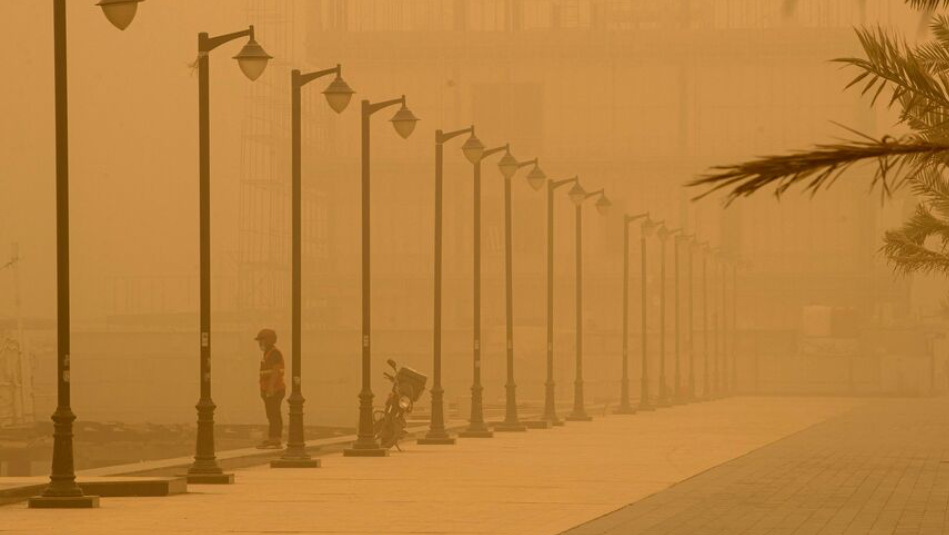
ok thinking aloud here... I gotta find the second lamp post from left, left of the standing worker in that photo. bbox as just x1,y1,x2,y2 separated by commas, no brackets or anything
187,26,270,484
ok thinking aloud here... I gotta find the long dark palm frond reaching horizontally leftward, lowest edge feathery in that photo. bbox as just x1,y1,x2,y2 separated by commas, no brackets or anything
688,136,949,202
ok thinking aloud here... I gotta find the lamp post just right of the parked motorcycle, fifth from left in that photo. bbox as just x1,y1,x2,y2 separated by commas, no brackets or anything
418,126,484,445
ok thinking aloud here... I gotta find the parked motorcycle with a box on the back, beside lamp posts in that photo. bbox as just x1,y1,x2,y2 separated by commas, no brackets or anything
372,359,428,451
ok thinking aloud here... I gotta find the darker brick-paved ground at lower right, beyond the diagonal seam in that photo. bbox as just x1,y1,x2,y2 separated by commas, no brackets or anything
566,398,949,535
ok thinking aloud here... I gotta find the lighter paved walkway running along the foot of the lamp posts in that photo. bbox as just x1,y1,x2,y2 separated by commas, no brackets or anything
0,398,863,535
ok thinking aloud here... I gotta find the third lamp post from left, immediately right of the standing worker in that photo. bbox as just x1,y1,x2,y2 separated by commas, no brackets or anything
270,64,353,468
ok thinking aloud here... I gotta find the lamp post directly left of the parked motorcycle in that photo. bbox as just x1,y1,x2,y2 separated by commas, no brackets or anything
343,95,418,457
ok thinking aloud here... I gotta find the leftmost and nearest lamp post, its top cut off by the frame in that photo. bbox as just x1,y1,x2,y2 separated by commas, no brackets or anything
29,0,140,509
